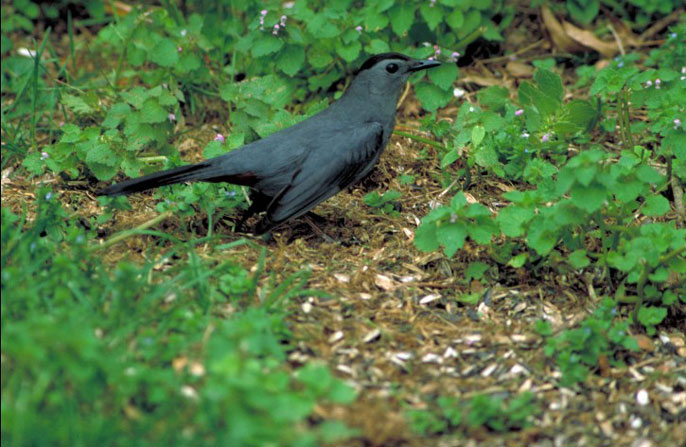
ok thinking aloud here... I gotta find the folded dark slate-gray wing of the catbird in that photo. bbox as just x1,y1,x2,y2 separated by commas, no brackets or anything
263,122,383,230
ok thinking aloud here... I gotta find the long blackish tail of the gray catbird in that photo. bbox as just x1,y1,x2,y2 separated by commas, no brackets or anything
97,160,231,196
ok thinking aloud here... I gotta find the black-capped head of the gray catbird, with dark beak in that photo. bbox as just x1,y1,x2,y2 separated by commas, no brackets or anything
351,53,440,96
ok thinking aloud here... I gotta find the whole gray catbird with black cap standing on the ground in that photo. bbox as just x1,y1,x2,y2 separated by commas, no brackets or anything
98,53,439,234
